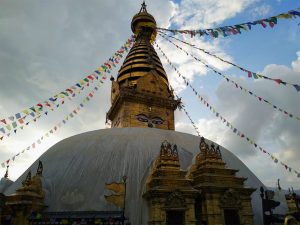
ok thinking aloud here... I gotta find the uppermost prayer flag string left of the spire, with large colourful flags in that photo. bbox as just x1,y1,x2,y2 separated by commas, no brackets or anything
0,36,134,141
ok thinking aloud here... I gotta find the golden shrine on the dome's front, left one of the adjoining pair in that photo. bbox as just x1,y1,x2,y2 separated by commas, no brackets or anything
143,141,198,225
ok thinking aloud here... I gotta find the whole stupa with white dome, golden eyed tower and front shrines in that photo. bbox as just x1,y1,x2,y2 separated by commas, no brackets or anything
1,3,288,225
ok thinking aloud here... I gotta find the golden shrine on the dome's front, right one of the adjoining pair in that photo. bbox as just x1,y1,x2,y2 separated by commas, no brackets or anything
189,138,255,225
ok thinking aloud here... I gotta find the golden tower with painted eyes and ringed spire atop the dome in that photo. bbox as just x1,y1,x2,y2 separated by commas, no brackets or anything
107,3,180,130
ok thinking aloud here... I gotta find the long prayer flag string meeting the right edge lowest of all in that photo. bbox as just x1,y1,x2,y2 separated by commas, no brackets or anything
155,43,300,178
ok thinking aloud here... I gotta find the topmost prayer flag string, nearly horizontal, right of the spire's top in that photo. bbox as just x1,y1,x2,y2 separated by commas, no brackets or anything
156,8,300,38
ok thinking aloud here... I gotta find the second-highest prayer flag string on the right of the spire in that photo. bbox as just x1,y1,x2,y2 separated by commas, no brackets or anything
159,31,300,92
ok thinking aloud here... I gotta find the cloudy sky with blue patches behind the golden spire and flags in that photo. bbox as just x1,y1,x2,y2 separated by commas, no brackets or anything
0,0,300,189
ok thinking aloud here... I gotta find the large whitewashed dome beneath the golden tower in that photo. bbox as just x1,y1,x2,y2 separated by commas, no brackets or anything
5,128,272,225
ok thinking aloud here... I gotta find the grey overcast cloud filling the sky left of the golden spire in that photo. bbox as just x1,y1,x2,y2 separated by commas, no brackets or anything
0,0,175,179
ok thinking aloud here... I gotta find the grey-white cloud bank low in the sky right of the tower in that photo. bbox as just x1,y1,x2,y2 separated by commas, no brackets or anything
177,52,300,186
